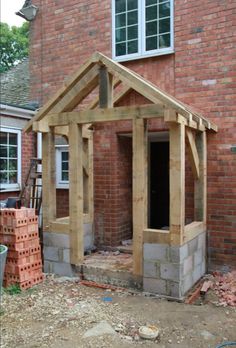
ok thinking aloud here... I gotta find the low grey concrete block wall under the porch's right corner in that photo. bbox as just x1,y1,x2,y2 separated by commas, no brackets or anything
143,232,206,298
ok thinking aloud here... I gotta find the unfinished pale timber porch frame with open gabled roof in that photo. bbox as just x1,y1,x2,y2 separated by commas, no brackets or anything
25,53,217,276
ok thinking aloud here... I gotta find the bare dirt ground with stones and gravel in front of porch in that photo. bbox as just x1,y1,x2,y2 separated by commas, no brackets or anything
0,277,236,348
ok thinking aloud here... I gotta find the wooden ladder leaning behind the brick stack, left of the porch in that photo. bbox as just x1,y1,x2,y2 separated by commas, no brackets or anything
19,158,42,215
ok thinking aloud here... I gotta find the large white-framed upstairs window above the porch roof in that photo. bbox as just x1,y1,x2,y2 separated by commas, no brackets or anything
112,0,174,61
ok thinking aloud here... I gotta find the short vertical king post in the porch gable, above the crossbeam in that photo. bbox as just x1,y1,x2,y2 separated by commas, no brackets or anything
99,66,113,108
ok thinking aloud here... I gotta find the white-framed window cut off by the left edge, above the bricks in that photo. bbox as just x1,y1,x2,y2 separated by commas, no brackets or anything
0,127,21,191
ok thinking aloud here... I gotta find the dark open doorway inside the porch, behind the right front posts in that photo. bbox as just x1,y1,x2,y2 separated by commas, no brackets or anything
149,142,170,229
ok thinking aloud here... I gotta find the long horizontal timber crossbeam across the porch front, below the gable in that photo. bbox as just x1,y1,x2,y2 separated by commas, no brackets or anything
45,104,164,126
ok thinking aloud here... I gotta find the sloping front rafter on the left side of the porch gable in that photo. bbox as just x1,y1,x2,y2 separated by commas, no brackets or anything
24,53,99,132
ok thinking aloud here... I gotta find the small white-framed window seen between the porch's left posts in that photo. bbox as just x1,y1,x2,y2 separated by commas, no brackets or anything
56,145,69,188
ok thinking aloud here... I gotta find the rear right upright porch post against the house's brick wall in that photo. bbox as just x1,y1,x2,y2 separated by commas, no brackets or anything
194,132,207,223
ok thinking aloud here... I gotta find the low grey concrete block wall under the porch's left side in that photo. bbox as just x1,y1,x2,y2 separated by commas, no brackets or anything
43,223,93,277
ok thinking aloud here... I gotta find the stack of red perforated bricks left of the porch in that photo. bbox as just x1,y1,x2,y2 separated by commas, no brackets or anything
0,208,43,290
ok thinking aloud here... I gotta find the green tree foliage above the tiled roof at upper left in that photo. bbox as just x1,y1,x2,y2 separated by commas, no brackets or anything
0,22,29,72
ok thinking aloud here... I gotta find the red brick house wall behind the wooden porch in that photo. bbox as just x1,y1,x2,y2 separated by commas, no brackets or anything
31,0,236,265
